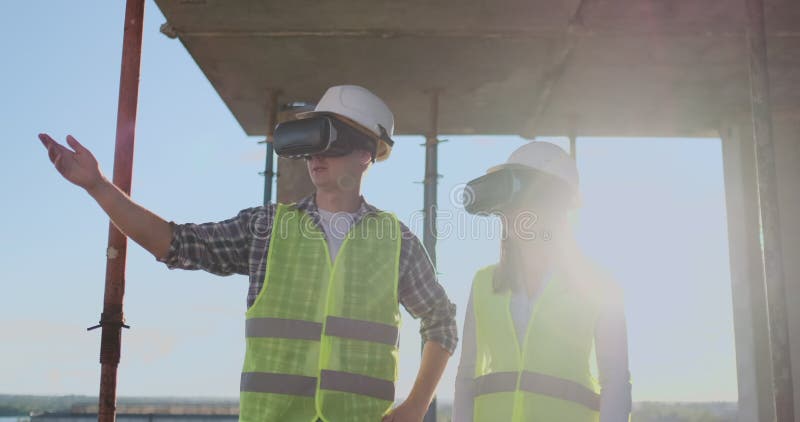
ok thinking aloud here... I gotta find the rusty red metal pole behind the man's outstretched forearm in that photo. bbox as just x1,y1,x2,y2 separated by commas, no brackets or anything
98,0,144,422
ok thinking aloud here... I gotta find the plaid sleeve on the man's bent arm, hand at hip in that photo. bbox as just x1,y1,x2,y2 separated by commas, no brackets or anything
398,224,458,354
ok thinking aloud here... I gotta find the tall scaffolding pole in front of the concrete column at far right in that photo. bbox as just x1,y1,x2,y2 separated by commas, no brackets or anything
745,0,795,422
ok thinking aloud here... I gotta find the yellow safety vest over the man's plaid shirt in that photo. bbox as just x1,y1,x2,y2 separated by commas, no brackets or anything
239,204,401,422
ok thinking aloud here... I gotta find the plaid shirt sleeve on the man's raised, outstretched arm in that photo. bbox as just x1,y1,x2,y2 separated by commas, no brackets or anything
157,206,274,276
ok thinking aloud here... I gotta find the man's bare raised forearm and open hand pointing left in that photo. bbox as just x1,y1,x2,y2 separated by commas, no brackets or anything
39,134,172,258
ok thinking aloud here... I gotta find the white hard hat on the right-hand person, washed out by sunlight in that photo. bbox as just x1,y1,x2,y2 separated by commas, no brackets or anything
487,141,578,193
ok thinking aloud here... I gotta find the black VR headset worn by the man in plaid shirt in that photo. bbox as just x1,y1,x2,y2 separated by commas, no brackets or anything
273,115,394,161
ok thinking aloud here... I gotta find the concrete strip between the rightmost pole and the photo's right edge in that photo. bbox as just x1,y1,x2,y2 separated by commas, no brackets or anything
772,112,800,422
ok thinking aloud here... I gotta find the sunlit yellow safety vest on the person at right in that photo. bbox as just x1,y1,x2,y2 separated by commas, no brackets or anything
472,266,600,422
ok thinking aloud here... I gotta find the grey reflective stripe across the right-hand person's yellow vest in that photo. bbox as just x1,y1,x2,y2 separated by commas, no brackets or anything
474,371,600,411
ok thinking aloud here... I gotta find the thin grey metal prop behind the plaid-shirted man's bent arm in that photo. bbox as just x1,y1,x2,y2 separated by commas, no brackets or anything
422,90,439,422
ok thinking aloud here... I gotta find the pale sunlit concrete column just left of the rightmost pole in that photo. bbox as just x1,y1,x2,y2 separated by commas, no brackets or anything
720,119,775,422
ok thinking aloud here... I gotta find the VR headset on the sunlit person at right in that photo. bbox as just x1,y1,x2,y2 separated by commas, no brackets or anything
462,165,574,215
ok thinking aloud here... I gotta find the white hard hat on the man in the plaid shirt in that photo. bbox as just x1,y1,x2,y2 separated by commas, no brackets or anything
297,85,394,161
